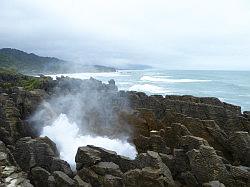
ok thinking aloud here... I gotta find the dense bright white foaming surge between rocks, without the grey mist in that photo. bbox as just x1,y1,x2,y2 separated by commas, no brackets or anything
41,114,137,167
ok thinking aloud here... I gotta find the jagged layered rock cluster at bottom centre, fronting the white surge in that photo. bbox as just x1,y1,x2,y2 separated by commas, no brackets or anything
76,146,175,187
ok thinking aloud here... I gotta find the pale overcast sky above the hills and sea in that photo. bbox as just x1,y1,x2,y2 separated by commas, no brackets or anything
0,0,250,70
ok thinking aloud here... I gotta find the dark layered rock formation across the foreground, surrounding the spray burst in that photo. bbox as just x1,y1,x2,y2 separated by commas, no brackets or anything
0,70,250,187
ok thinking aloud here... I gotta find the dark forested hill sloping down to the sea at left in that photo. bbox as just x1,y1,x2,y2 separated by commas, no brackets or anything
0,48,116,74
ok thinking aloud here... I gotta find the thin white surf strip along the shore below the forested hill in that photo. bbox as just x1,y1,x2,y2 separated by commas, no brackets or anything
46,72,130,79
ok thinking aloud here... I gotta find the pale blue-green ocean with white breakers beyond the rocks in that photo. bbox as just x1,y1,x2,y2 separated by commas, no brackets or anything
49,69,250,111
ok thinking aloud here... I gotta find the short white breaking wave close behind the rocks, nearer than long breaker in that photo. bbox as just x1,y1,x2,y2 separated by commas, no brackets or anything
129,84,170,94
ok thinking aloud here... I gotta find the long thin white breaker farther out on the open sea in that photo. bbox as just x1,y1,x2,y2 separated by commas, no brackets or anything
140,76,211,83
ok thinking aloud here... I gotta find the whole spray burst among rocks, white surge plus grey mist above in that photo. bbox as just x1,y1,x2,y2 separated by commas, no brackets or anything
31,76,137,167
